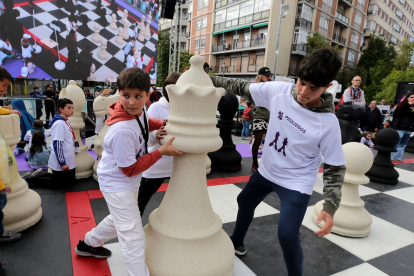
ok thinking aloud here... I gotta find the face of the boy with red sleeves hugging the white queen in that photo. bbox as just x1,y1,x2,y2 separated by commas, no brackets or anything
120,88,148,116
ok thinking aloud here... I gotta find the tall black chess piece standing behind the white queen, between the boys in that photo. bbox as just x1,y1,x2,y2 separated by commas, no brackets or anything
208,93,242,172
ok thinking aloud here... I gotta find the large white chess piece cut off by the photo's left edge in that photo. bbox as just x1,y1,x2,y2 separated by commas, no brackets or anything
0,114,42,232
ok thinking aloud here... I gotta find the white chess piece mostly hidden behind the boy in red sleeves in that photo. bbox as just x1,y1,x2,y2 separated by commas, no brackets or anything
93,91,119,181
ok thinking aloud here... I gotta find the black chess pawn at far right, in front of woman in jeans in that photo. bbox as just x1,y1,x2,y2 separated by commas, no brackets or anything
366,128,400,185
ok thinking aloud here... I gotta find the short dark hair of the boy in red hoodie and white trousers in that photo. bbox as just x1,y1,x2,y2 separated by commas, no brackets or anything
116,67,151,93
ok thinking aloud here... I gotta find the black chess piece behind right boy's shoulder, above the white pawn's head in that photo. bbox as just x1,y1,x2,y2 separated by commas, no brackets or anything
336,102,366,145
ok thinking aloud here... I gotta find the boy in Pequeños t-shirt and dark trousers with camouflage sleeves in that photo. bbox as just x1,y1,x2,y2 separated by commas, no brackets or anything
211,49,345,276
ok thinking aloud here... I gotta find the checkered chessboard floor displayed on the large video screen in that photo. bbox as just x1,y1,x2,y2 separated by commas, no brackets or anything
3,0,158,81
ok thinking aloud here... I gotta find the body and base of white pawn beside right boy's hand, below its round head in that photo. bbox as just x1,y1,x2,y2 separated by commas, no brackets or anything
312,183,372,238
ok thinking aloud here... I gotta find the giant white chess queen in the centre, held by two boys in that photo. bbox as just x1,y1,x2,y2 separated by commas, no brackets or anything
144,56,234,276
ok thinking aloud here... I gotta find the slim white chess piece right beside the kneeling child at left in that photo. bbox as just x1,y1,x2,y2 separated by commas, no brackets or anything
66,80,95,179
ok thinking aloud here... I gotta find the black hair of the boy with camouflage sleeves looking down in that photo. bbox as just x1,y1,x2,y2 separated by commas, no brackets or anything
298,48,342,87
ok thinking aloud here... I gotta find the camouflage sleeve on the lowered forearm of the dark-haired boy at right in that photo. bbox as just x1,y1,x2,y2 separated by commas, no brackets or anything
322,163,346,217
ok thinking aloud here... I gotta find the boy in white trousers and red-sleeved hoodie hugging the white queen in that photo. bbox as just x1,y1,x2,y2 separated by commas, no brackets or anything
75,67,183,276
